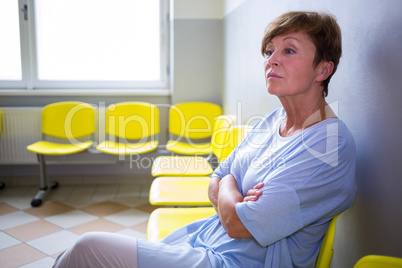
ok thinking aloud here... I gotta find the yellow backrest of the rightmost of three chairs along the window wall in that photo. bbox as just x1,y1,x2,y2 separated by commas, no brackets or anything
169,102,222,139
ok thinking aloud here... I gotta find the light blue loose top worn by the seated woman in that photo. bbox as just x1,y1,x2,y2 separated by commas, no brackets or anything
139,109,356,268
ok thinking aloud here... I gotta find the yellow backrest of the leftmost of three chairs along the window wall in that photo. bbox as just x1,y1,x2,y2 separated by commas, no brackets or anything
42,101,95,139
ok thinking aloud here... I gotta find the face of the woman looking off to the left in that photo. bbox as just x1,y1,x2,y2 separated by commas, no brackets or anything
264,33,319,97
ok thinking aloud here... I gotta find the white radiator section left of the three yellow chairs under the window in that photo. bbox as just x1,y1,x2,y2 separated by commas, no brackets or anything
0,107,42,164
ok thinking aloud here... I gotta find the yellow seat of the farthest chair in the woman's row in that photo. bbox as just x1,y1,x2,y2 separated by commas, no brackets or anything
152,156,213,177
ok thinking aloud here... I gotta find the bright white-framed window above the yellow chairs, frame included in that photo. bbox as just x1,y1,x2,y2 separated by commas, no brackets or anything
0,0,169,90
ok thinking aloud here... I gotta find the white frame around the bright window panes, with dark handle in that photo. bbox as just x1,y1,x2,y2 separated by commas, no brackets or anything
0,0,170,95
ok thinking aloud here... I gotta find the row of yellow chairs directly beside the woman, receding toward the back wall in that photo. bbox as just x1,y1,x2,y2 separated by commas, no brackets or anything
147,115,249,241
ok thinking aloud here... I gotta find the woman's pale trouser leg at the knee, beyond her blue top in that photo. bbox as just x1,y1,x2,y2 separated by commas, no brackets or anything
53,232,138,268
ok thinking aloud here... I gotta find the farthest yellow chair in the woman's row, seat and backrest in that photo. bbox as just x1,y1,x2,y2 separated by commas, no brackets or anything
152,115,235,177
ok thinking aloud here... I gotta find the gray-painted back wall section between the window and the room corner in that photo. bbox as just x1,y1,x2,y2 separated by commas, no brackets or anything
172,19,223,105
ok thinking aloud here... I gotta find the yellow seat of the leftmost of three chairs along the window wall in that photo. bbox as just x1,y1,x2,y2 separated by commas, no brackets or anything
27,141,93,155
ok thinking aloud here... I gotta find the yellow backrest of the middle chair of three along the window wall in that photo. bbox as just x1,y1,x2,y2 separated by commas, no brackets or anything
106,102,159,140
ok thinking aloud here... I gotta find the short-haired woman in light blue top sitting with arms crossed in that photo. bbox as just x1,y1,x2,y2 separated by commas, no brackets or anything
55,12,356,268
